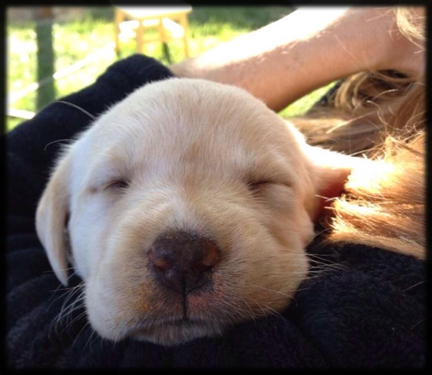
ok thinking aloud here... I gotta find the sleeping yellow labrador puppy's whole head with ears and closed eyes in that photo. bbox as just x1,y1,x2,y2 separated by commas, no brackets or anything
36,78,363,345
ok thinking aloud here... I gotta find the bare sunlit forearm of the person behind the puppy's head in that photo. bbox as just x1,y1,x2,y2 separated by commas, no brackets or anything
171,7,421,111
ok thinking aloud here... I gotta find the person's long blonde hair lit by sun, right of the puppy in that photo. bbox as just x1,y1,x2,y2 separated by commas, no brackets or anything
294,8,425,259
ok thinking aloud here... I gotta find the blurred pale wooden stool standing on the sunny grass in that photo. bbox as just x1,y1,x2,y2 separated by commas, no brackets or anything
114,4,192,57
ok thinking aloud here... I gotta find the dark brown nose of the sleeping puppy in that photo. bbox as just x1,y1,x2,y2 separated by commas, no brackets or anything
148,231,220,295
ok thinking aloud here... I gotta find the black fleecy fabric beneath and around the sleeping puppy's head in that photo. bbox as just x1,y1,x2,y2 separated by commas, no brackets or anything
6,55,426,368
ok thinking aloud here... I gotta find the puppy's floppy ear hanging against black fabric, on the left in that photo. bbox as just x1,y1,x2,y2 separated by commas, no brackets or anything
36,156,70,286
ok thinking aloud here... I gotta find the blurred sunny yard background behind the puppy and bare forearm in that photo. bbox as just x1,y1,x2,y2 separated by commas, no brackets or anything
6,6,327,131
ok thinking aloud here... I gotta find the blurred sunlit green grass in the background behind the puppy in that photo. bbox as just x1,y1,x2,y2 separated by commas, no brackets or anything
6,7,326,134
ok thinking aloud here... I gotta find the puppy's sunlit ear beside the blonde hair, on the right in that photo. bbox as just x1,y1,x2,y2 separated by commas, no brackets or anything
305,145,371,220
